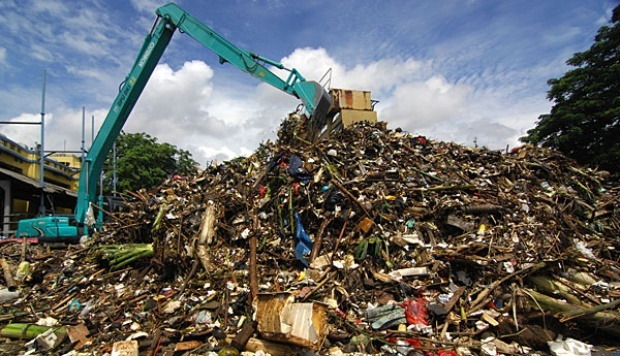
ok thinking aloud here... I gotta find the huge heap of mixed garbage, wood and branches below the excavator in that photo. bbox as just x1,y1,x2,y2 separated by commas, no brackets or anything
0,115,620,355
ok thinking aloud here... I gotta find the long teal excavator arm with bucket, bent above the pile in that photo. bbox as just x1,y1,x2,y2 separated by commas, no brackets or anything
75,3,332,224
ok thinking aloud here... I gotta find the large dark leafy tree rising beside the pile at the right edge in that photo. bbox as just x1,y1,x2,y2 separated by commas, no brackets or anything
521,5,620,177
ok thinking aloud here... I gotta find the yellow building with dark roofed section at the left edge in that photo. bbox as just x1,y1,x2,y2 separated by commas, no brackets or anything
0,134,81,236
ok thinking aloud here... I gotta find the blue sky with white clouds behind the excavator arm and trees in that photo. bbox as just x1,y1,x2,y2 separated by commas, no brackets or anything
0,0,618,167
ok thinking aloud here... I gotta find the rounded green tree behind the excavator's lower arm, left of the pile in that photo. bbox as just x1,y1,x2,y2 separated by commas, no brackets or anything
103,132,198,195
